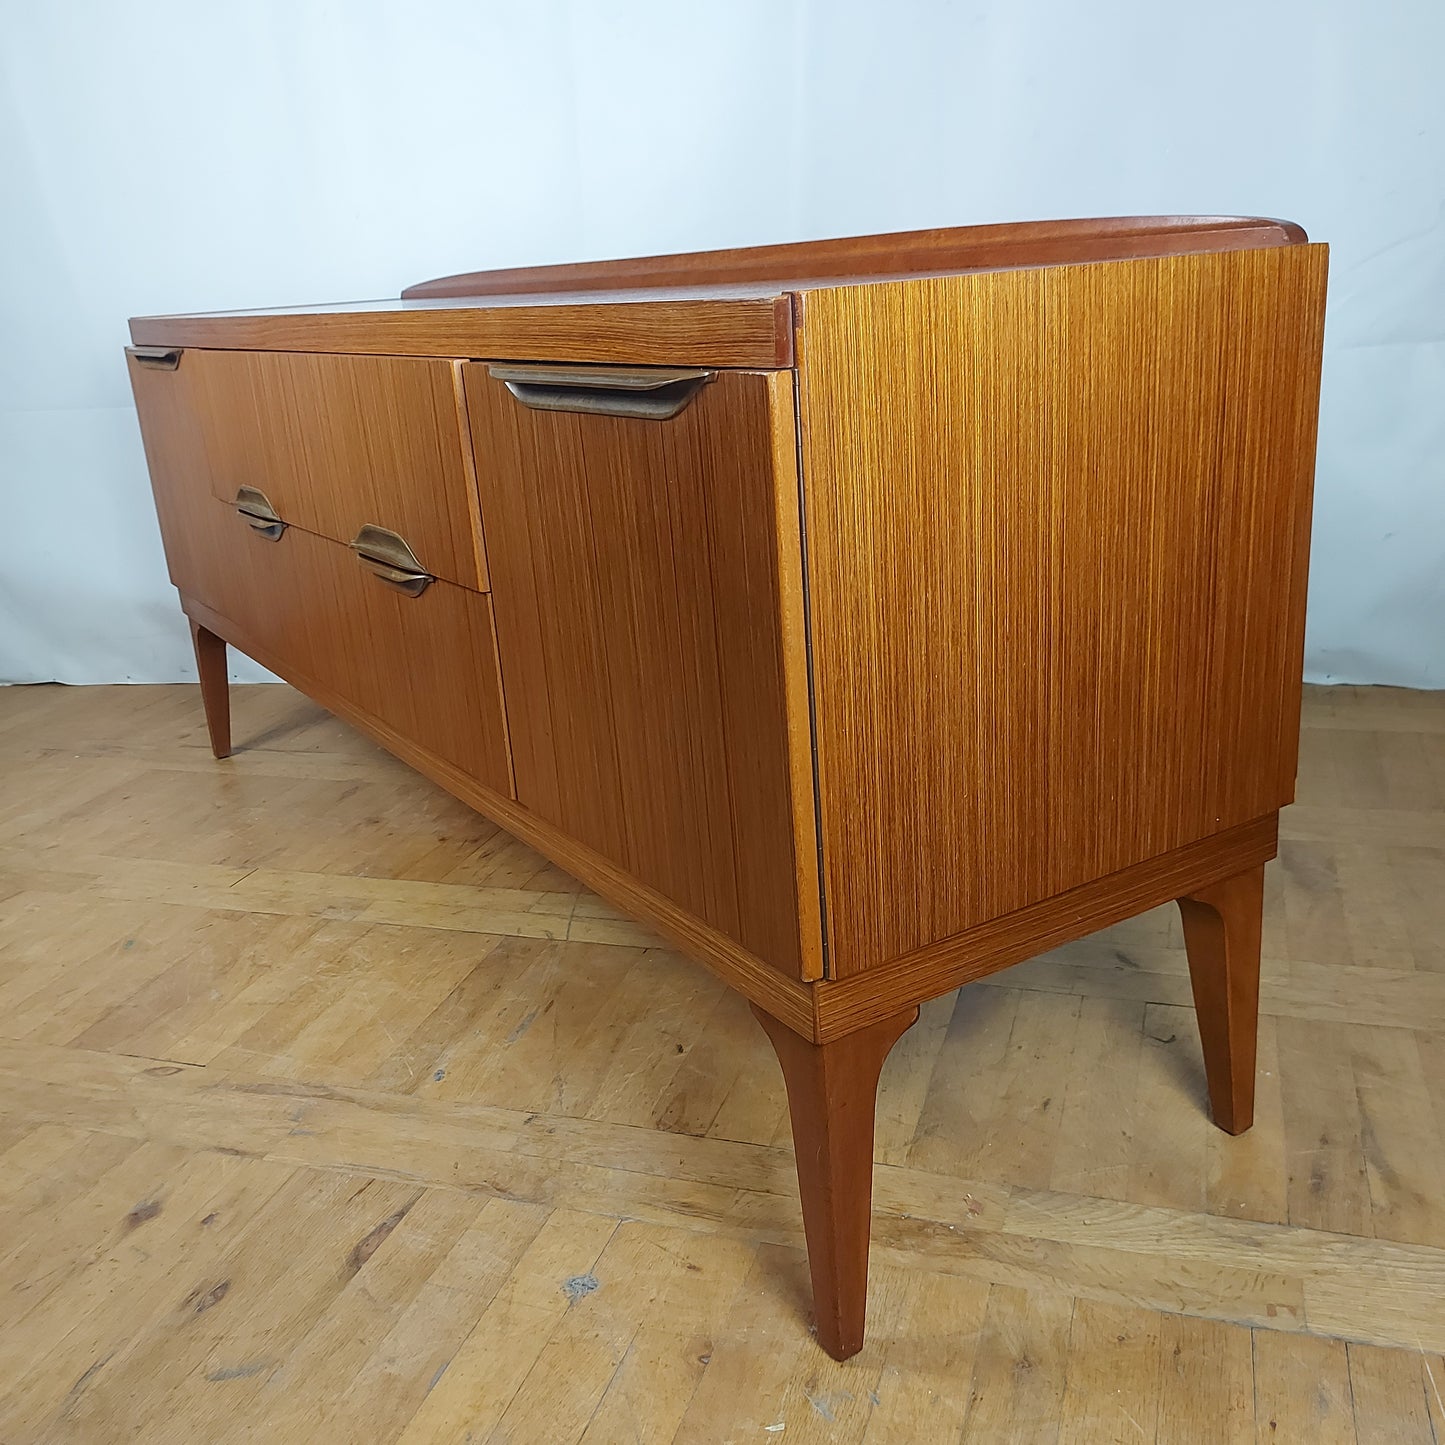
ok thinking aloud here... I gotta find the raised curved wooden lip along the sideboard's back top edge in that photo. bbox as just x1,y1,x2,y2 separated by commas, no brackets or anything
402,215,1309,301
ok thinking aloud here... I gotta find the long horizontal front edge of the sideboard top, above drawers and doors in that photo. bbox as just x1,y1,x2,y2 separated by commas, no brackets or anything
130,288,793,367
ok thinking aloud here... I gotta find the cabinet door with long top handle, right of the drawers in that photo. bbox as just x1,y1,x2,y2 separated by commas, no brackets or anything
462,363,822,978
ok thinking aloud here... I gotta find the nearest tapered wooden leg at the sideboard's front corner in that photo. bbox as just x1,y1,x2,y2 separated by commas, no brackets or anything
753,1004,918,1360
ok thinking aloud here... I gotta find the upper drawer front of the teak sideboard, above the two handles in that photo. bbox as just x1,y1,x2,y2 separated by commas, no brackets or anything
175,350,487,591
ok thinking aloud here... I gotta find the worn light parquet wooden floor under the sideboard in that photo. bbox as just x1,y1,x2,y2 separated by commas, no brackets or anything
0,686,1445,1445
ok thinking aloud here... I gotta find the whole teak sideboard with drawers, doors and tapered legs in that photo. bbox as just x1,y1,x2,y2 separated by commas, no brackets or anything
129,217,1327,1358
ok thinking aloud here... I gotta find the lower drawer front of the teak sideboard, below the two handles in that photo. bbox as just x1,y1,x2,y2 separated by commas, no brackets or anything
198,499,513,798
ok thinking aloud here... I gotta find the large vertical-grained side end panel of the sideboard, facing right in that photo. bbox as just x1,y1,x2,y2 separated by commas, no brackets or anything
799,246,1325,978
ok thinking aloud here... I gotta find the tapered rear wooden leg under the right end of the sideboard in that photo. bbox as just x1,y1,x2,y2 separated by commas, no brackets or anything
1179,864,1264,1134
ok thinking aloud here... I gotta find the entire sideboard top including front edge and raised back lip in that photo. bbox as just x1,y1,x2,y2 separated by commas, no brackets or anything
130,217,1306,367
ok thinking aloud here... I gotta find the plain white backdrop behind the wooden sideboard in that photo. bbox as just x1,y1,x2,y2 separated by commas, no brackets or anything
0,0,1445,688
